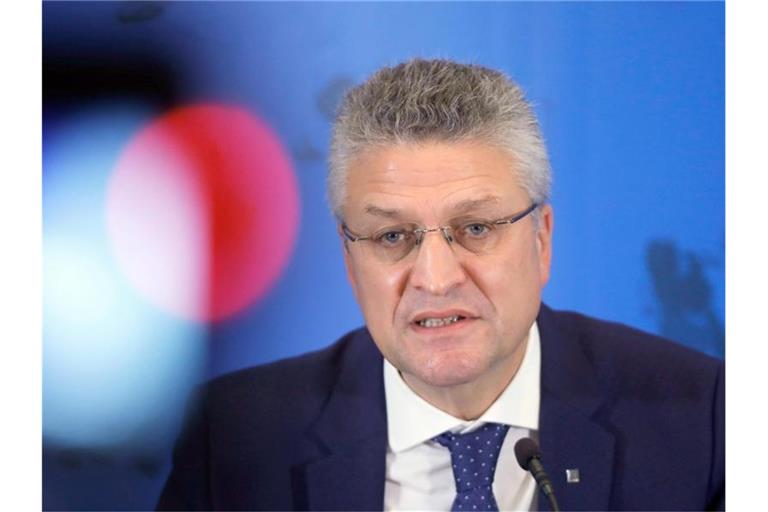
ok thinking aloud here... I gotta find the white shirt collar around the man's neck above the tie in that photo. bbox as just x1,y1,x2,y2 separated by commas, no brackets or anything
384,322,541,453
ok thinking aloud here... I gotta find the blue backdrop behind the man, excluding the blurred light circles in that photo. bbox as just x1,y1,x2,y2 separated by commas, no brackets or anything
43,2,725,510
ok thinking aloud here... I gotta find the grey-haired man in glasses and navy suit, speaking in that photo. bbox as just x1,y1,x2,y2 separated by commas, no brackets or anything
158,60,724,510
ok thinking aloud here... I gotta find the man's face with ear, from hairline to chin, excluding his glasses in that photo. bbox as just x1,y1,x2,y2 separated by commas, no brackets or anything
343,142,552,391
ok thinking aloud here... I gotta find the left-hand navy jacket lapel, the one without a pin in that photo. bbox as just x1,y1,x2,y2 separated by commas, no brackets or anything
301,330,387,510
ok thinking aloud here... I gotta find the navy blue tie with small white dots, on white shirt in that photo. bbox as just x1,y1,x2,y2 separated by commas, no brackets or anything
434,423,509,512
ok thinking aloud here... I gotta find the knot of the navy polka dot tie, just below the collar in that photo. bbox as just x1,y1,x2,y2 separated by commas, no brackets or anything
434,423,509,493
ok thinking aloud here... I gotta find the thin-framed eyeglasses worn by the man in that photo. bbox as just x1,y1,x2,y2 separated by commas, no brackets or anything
341,203,539,263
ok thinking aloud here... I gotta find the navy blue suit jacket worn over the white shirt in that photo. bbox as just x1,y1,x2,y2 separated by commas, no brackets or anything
158,306,725,510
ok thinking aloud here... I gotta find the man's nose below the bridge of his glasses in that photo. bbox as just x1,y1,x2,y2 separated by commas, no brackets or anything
409,229,467,295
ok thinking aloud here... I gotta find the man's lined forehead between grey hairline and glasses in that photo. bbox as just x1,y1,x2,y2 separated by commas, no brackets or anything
343,141,529,219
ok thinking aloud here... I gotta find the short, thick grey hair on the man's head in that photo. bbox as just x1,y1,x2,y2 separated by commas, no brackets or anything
327,59,551,219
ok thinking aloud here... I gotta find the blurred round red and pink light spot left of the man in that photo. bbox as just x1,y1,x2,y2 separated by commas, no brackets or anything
107,104,299,321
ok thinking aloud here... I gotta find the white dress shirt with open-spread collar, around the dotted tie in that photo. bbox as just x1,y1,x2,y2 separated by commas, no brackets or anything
384,322,541,510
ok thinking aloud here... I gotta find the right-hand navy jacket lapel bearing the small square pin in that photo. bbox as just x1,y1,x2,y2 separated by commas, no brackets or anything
537,304,615,510
